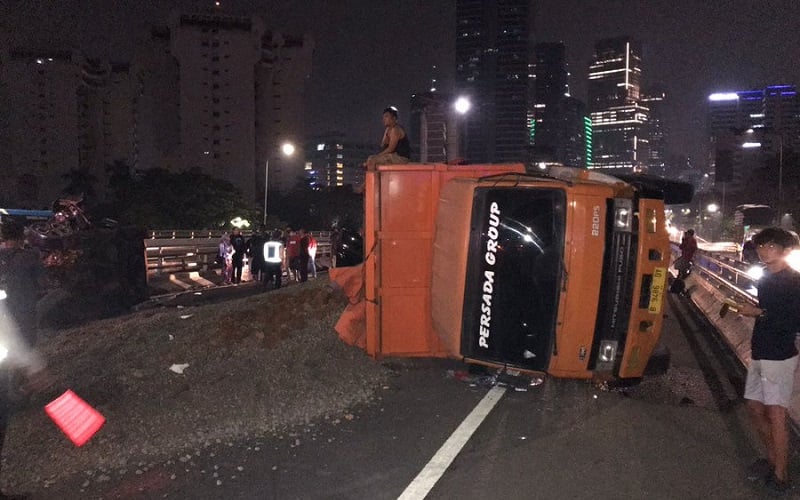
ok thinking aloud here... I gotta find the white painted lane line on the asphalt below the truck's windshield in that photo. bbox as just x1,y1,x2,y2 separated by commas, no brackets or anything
398,386,506,500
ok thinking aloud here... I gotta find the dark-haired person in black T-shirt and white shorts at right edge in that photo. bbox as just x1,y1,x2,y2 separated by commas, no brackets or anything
738,227,800,492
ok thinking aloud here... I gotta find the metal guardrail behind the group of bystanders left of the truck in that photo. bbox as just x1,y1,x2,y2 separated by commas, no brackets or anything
144,230,331,276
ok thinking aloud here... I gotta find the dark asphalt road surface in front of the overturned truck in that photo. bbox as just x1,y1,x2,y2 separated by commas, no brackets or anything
47,287,800,500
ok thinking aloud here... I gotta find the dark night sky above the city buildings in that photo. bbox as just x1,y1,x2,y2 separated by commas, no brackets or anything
0,0,800,170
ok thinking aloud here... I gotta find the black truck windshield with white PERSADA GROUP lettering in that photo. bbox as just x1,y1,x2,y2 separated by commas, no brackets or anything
462,187,565,370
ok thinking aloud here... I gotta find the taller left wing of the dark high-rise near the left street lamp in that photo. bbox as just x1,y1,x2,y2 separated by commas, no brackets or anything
170,12,264,200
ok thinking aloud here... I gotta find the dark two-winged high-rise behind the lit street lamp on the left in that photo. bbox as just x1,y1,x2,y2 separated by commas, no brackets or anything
170,11,313,200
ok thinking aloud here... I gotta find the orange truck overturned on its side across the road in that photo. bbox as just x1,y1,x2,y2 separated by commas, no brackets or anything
337,164,692,378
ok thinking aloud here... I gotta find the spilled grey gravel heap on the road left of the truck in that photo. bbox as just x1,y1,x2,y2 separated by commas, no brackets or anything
2,278,388,492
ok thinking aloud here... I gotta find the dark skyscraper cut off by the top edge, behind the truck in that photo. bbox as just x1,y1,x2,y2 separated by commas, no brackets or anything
455,0,531,163
